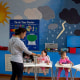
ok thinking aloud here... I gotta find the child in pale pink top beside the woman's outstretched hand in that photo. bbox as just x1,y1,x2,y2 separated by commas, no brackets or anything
37,50,50,75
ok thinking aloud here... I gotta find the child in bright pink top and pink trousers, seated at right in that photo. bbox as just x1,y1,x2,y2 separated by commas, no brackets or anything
57,51,73,80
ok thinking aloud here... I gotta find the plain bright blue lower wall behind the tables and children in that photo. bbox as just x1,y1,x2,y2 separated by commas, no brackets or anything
0,51,80,78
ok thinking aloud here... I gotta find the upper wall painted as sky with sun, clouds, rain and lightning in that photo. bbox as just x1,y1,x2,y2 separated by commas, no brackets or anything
0,0,80,50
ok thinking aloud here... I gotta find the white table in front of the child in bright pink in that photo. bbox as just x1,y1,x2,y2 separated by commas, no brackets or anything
55,62,72,80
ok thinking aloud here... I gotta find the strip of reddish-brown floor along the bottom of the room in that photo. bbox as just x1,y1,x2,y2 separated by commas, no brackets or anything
0,75,80,80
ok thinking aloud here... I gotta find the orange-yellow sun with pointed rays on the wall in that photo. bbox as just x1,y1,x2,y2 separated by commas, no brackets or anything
0,1,11,25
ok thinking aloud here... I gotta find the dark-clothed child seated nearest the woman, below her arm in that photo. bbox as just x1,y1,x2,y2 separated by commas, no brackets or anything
23,52,34,74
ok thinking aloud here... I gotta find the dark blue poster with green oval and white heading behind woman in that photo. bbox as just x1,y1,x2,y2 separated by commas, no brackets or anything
10,20,39,50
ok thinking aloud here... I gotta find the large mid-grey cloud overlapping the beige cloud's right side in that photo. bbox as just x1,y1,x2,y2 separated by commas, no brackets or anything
38,6,55,20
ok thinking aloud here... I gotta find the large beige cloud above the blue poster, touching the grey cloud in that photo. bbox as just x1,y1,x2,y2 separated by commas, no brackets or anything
24,8,42,19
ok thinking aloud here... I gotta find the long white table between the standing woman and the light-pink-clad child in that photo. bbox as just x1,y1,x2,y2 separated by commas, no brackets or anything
24,62,53,80
